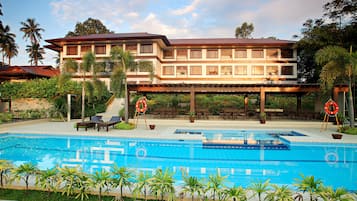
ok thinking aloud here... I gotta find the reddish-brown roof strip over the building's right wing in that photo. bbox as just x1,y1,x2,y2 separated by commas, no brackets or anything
169,38,295,46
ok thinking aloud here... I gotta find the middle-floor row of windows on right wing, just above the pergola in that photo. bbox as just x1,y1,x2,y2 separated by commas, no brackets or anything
162,65,294,77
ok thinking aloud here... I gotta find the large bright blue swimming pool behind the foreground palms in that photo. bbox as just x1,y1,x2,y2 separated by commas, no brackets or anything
0,133,357,190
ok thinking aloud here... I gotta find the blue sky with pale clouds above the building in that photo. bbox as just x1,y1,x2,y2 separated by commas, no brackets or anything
0,0,328,66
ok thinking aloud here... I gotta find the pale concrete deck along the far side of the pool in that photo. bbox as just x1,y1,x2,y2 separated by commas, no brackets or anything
0,119,357,144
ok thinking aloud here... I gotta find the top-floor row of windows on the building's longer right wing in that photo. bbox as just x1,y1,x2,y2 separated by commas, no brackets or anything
164,48,294,59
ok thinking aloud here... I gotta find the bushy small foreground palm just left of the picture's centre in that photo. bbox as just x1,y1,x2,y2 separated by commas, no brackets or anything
150,169,175,200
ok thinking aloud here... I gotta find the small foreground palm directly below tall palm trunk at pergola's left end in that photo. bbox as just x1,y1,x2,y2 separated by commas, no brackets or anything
111,165,133,199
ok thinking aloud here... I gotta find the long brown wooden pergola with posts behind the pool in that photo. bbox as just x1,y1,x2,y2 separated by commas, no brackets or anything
128,83,348,114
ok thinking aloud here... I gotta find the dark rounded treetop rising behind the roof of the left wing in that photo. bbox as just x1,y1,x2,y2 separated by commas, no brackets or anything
66,18,113,37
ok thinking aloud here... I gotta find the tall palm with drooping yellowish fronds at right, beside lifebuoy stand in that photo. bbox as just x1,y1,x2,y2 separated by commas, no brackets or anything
315,46,357,127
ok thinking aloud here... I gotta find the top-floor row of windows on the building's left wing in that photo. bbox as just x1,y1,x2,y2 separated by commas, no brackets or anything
66,43,153,56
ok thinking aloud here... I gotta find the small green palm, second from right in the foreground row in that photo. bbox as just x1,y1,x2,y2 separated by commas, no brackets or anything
294,174,322,201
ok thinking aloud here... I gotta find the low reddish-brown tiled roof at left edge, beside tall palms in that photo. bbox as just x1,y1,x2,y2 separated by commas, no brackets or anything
0,66,60,77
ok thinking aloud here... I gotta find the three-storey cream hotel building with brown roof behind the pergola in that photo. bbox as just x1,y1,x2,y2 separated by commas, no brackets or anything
46,33,297,86
